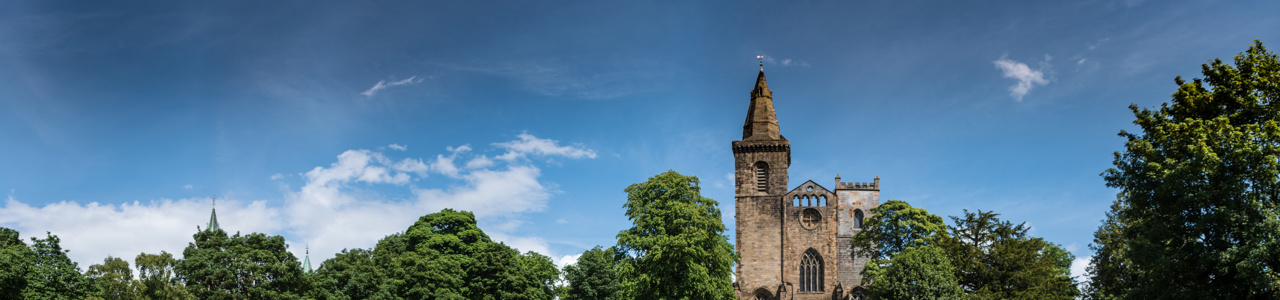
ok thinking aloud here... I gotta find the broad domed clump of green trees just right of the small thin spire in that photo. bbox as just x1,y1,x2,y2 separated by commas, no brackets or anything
312,209,559,299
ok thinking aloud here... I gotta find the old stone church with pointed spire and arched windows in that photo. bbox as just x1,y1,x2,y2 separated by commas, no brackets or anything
733,68,879,300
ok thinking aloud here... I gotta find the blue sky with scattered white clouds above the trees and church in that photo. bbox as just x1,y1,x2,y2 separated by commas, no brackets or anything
0,0,1280,275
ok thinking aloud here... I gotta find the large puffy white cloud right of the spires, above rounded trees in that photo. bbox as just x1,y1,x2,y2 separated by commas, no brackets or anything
284,136,594,260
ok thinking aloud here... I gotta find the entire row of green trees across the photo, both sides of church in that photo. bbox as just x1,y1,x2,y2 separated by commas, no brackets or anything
0,41,1280,300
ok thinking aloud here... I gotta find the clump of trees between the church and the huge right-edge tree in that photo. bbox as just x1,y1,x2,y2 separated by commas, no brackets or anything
852,200,1079,299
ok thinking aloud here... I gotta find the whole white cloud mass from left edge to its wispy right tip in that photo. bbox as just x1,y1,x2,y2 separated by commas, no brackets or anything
0,135,594,268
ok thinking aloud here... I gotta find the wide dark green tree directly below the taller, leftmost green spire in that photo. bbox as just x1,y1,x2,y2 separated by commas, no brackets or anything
174,229,306,299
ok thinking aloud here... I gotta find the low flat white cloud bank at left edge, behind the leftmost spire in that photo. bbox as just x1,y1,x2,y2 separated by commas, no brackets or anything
0,196,282,269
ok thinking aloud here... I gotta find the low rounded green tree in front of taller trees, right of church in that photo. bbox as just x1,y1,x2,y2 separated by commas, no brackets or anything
867,245,964,300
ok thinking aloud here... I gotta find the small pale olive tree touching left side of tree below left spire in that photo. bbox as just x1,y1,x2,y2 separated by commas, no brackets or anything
133,251,195,300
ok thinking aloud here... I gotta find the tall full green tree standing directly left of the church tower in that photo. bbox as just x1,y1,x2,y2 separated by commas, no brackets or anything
617,171,737,299
